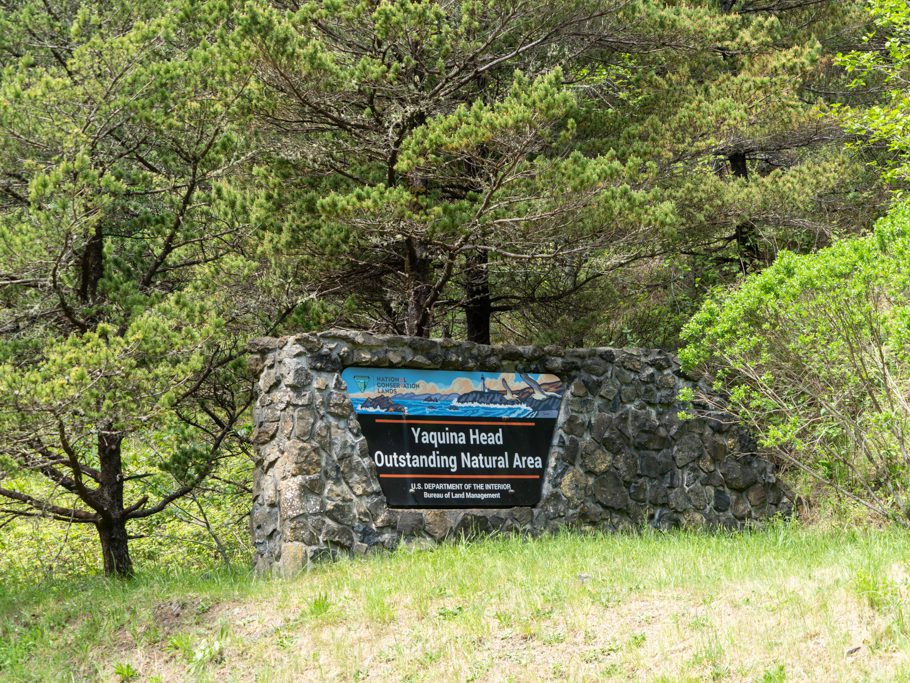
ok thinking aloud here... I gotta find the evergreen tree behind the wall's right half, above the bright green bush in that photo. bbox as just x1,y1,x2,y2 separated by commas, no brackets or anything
513,1,887,348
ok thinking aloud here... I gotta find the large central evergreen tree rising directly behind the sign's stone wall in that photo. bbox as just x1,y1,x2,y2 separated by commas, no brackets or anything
246,0,667,342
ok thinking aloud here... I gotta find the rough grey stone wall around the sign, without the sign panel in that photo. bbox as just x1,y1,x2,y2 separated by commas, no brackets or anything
250,332,792,573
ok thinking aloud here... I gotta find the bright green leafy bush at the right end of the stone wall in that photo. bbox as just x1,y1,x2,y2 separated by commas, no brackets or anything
681,204,910,522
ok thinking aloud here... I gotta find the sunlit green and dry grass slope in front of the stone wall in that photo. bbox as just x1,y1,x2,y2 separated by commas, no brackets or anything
0,524,910,683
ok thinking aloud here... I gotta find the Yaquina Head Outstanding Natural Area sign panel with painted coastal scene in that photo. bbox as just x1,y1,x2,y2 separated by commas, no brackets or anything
342,367,564,508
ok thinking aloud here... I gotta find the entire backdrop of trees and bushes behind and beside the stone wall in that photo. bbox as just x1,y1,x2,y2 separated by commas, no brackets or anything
0,0,910,577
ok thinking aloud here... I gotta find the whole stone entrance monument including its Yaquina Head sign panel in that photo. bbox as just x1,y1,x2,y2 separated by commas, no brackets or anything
251,332,792,573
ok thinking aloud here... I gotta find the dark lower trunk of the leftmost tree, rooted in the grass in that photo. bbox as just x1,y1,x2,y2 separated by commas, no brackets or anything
95,422,133,577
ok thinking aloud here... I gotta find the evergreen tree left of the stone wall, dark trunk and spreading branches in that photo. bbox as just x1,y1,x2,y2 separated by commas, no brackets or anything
0,0,274,576
